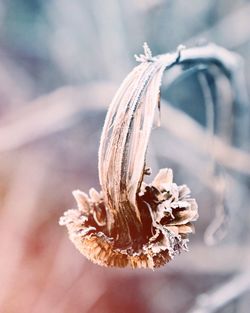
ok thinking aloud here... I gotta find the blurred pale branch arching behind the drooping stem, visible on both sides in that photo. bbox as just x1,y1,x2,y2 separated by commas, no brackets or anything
0,84,250,175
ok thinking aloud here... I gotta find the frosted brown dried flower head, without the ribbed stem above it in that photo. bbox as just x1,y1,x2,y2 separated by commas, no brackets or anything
60,169,198,268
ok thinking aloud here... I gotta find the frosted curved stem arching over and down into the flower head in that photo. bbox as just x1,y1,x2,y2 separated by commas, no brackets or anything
99,44,248,243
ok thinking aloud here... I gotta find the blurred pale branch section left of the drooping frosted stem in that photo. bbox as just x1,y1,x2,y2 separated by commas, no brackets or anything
0,83,114,152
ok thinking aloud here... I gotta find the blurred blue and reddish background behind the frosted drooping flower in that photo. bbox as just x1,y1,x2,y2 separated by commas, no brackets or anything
0,0,250,313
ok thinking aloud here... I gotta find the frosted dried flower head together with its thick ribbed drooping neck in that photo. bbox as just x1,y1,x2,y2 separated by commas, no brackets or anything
60,44,198,269
